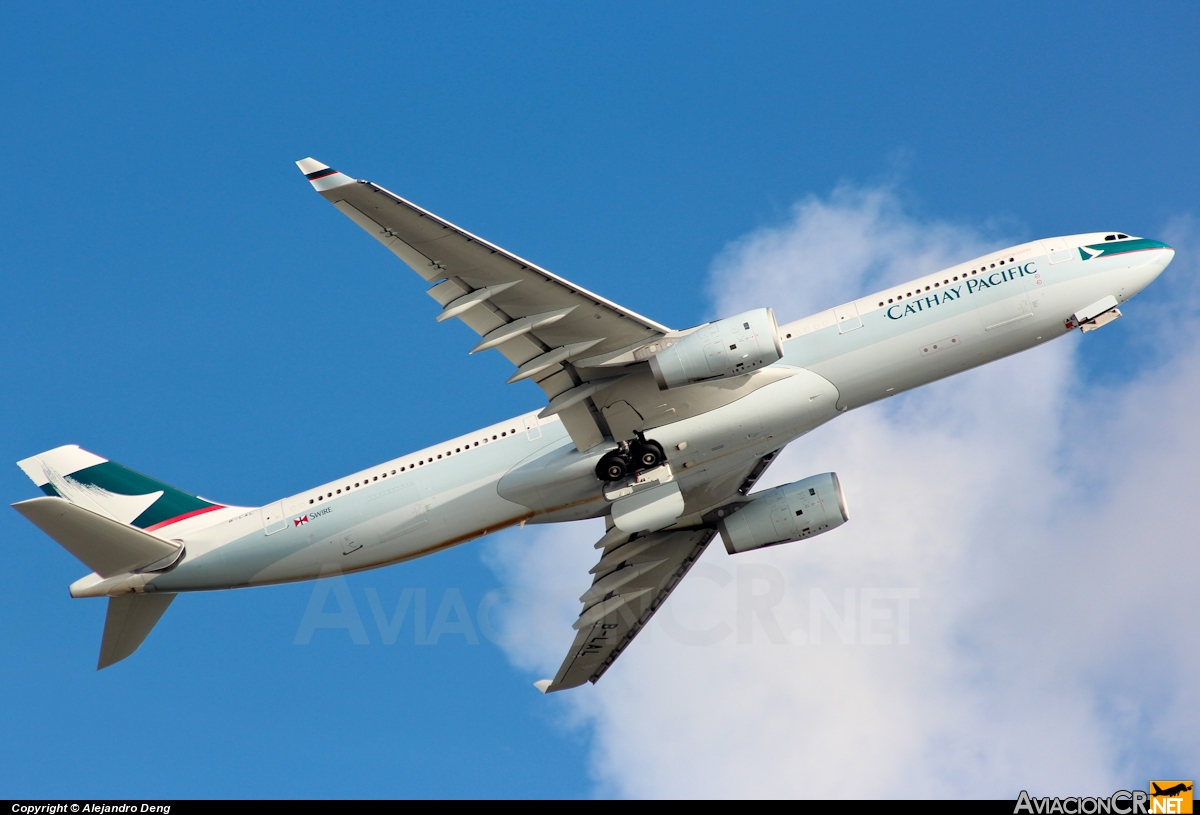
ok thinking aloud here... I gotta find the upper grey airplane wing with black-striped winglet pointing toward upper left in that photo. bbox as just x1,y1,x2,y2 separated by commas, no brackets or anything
296,158,670,450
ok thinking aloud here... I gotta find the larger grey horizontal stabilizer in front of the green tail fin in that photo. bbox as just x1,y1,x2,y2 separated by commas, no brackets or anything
12,498,180,580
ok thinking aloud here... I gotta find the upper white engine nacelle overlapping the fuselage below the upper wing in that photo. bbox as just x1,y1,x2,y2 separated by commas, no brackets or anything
650,308,784,390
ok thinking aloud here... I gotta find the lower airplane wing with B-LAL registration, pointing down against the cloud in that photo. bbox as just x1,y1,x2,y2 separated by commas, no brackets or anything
535,453,775,693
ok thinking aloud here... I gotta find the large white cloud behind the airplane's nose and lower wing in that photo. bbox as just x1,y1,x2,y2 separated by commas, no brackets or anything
486,187,1200,797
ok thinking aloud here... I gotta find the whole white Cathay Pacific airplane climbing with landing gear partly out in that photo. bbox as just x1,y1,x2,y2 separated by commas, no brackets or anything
13,158,1175,693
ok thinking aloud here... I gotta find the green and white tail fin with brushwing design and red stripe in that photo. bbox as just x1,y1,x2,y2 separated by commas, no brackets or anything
17,444,223,532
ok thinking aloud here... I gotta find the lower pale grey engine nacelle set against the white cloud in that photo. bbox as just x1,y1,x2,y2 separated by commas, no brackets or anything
718,473,850,555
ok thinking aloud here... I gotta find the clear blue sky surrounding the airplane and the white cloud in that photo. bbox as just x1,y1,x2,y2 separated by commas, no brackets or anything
0,2,1200,797
